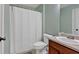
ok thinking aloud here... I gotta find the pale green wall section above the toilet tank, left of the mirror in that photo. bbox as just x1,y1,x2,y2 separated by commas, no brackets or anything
45,4,60,35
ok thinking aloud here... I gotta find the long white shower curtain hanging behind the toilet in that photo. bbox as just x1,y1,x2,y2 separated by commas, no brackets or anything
10,7,42,53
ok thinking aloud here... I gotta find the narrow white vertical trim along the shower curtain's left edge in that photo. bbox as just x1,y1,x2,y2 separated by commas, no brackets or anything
9,6,15,54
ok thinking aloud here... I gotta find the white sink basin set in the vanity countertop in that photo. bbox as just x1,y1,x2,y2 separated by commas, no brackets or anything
56,37,79,45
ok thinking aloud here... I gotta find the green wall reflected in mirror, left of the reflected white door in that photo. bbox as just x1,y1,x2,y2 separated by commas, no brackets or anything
60,4,79,33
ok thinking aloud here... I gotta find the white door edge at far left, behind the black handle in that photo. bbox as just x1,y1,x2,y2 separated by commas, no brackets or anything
0,4,5,54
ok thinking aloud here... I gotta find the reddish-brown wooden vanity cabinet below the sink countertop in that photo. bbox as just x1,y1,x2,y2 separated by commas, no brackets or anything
49,40,79,54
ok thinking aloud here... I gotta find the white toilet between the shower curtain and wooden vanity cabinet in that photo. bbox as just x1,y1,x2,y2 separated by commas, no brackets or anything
33,34,52,54
